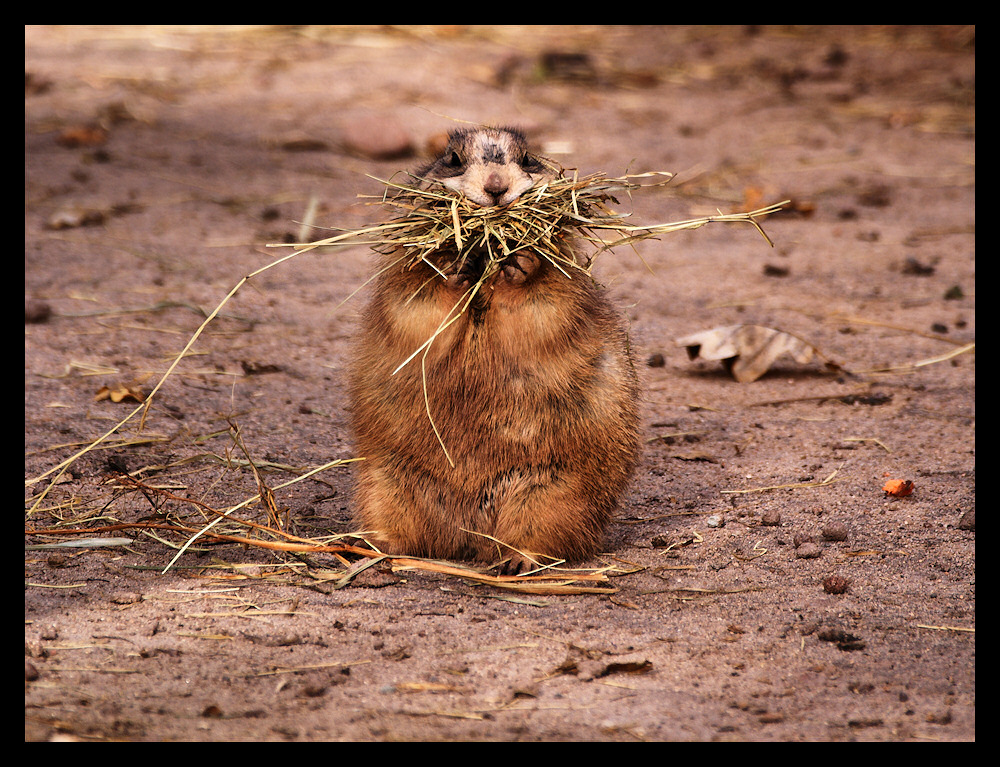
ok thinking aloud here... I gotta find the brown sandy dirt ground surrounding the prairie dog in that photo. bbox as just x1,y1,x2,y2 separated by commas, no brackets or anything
24,26,975,742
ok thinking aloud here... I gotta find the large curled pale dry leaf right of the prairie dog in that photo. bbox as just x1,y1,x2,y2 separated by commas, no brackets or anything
677,325,818,383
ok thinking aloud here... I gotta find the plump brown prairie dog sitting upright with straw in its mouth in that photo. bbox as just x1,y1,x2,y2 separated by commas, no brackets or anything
350,128,639,572
